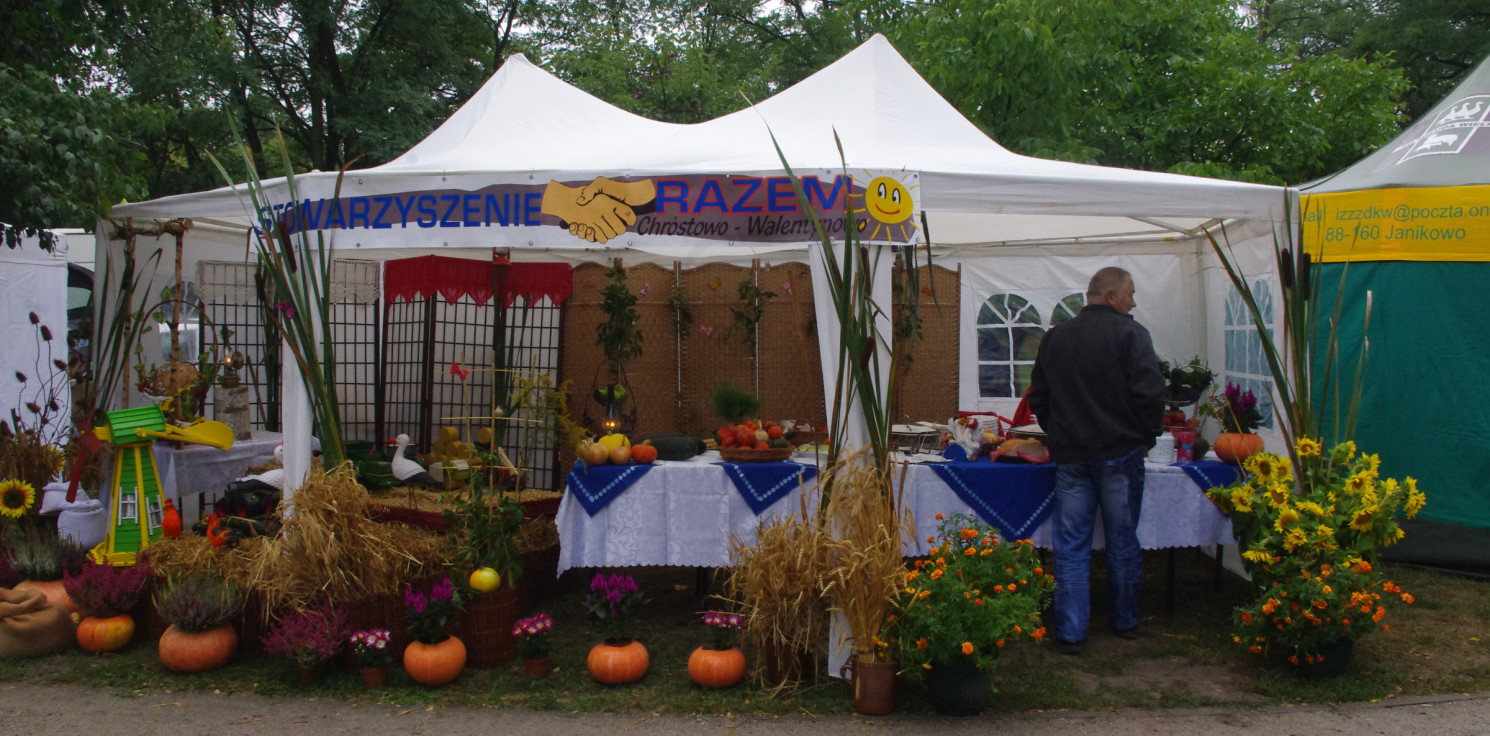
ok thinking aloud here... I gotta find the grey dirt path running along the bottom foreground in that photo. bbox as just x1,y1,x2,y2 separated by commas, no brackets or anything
0,682,1490,736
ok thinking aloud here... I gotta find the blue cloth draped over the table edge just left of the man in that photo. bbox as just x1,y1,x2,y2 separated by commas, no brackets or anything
931,460,1055,539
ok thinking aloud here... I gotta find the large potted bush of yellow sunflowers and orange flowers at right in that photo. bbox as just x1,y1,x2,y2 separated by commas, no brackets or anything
1207,437,1426,675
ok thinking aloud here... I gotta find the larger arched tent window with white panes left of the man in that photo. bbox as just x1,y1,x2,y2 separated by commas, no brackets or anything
977,294,1070,399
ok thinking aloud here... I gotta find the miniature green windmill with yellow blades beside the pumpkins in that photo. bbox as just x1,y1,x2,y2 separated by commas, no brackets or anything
92,404,232,566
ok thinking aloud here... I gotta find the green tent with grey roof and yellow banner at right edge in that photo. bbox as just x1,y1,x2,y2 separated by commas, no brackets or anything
1299,60,1490,575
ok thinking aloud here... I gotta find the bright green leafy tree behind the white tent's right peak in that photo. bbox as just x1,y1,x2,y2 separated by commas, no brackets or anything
893,0,1404,182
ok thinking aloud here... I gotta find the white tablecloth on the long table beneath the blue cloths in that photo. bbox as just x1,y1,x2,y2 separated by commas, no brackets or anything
557,453,1235,572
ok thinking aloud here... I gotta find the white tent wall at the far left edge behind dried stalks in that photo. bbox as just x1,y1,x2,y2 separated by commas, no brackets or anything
0,226,72,449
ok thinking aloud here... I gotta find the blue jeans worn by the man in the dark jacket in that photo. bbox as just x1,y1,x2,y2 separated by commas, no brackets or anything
1052,450,1143,642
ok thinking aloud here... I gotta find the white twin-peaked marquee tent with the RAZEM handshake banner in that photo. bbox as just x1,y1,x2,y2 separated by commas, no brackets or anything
98,36,1290,494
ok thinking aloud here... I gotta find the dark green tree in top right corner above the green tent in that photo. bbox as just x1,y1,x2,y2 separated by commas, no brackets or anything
1252,0,1490,121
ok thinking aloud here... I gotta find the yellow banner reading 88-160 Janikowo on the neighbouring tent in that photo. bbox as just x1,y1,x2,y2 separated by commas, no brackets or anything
1302,186,1490,262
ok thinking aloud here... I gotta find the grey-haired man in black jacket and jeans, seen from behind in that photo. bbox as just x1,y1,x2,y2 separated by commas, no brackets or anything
1030,268,1164,654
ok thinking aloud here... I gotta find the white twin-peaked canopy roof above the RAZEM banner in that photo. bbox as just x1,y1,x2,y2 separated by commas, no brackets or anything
113,36,1283,255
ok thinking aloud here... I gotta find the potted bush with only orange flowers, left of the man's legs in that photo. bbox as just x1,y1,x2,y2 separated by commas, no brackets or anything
895,514,1055,715
